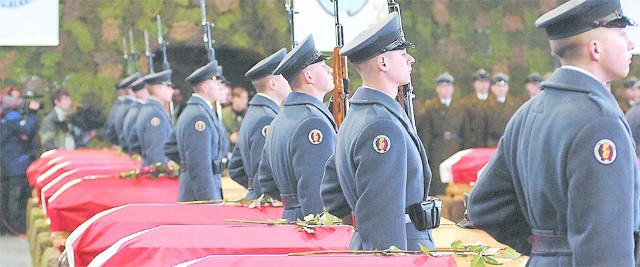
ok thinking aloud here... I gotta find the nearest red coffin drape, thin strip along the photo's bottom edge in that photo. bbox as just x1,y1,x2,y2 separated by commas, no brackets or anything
175,254,456,267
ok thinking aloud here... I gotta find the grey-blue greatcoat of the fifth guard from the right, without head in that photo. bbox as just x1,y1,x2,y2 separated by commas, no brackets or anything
164,94,223,201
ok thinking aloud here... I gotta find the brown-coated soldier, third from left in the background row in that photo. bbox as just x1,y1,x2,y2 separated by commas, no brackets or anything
487,72,522,147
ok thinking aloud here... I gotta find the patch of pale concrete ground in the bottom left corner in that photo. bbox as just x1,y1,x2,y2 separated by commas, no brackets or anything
0,235,31,267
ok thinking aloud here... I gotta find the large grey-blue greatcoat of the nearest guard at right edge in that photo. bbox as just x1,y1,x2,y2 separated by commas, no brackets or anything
468,67,640,266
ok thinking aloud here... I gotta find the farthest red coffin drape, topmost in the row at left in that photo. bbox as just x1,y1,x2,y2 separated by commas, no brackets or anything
27,149,120,186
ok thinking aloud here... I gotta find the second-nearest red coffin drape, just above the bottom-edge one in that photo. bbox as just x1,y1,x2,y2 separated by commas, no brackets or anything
89,225,353,266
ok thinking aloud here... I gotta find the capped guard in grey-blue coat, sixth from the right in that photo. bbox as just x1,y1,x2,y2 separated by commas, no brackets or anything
131,69,173,166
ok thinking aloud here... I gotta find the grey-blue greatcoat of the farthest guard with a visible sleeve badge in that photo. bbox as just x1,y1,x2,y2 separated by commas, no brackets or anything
136,98,173,166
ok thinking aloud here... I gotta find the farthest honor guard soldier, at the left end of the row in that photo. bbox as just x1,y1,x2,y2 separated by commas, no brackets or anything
104,72,140,145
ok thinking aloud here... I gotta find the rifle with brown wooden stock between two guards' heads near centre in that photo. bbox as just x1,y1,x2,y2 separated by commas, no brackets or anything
332,0,349,127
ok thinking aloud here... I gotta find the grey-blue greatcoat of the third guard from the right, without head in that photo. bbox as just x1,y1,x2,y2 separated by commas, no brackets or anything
258,92,336,221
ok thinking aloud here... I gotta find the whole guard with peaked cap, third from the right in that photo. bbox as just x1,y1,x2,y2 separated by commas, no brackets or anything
258,35,336,221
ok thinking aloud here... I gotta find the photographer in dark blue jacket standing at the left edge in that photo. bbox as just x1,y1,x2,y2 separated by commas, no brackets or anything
0,87,40,235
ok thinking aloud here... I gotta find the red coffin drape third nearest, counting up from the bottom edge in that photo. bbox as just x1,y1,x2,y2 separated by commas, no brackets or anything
65,204,282,266
